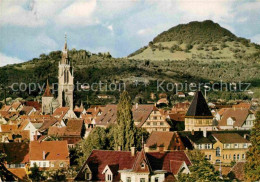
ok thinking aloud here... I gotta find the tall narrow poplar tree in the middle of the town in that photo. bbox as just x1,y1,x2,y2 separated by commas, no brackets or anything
115,91,136,150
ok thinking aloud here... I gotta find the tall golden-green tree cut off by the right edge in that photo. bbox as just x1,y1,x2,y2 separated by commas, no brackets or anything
245,111,260,181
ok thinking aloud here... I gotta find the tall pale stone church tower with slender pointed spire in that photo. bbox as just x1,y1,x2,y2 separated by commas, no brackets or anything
58,35,74,110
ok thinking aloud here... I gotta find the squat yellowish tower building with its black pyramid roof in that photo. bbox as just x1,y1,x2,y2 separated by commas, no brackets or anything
185,91,214,131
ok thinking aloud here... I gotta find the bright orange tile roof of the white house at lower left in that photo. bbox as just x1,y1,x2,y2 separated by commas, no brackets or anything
30,141,69,160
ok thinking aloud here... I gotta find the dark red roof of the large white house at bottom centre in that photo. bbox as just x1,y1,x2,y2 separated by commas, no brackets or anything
75,150,191,181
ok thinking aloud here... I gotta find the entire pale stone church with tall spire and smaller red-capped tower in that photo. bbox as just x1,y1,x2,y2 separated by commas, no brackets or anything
42,36,74,114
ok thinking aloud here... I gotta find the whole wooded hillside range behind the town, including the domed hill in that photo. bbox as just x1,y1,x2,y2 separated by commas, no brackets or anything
0,21,260,104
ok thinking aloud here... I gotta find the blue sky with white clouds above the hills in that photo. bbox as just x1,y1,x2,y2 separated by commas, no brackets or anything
0,0,260,67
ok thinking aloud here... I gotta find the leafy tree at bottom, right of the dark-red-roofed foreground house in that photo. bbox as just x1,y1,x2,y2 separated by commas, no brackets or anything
178,150,221,182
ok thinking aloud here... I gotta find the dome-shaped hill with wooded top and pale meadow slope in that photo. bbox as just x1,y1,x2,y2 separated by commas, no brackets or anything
128,20,260,61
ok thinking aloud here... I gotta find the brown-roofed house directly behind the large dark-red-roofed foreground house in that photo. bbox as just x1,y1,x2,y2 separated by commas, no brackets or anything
145,131,186,152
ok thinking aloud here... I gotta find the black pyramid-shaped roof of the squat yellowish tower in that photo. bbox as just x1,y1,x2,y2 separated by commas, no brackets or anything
186,91,213,118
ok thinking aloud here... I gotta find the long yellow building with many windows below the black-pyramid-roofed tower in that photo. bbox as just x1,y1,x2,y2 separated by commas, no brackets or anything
182,131,251,165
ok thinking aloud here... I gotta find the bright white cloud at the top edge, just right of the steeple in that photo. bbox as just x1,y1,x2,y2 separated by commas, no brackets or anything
55,0,99,26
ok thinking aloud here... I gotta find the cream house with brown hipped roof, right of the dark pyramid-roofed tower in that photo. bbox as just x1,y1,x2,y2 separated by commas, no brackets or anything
218,107,256,130
